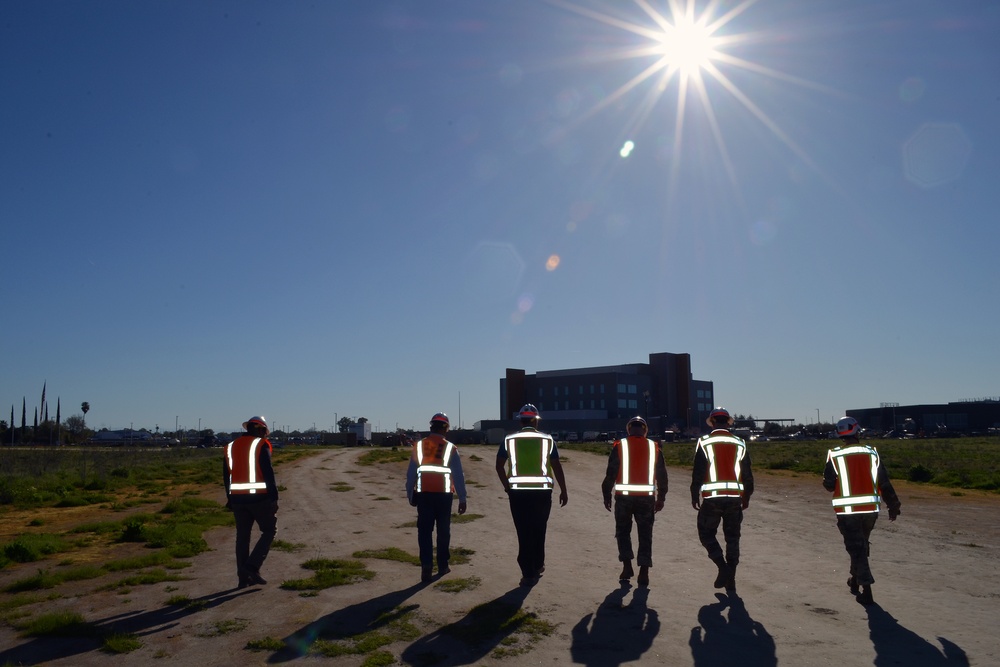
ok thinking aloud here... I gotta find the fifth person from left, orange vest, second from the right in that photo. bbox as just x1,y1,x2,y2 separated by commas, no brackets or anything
691,407,753,593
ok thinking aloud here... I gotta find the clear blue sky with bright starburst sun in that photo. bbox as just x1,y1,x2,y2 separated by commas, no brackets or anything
0,0,1000,430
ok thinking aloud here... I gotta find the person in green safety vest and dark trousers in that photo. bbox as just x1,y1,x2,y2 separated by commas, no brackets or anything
496,403,569,586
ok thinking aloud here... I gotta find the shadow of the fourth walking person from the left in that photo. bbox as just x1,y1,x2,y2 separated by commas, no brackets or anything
570,581,660,667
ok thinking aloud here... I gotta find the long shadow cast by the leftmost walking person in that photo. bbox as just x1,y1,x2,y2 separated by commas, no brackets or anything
0,588,254,665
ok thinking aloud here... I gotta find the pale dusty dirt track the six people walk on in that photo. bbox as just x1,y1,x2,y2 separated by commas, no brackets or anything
0,447,1000,667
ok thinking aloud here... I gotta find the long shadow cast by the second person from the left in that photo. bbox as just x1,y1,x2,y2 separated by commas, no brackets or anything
267,582,429,663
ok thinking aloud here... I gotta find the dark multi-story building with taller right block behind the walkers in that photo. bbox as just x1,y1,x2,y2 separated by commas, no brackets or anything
477,352,714,435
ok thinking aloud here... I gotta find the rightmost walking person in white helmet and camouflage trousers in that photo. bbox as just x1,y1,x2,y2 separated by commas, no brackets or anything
823,417,900,605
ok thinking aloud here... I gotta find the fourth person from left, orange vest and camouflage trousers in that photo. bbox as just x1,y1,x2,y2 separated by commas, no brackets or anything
601,417,667,586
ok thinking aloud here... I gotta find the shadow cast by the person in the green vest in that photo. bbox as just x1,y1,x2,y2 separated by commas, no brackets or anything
400,586,531,667
